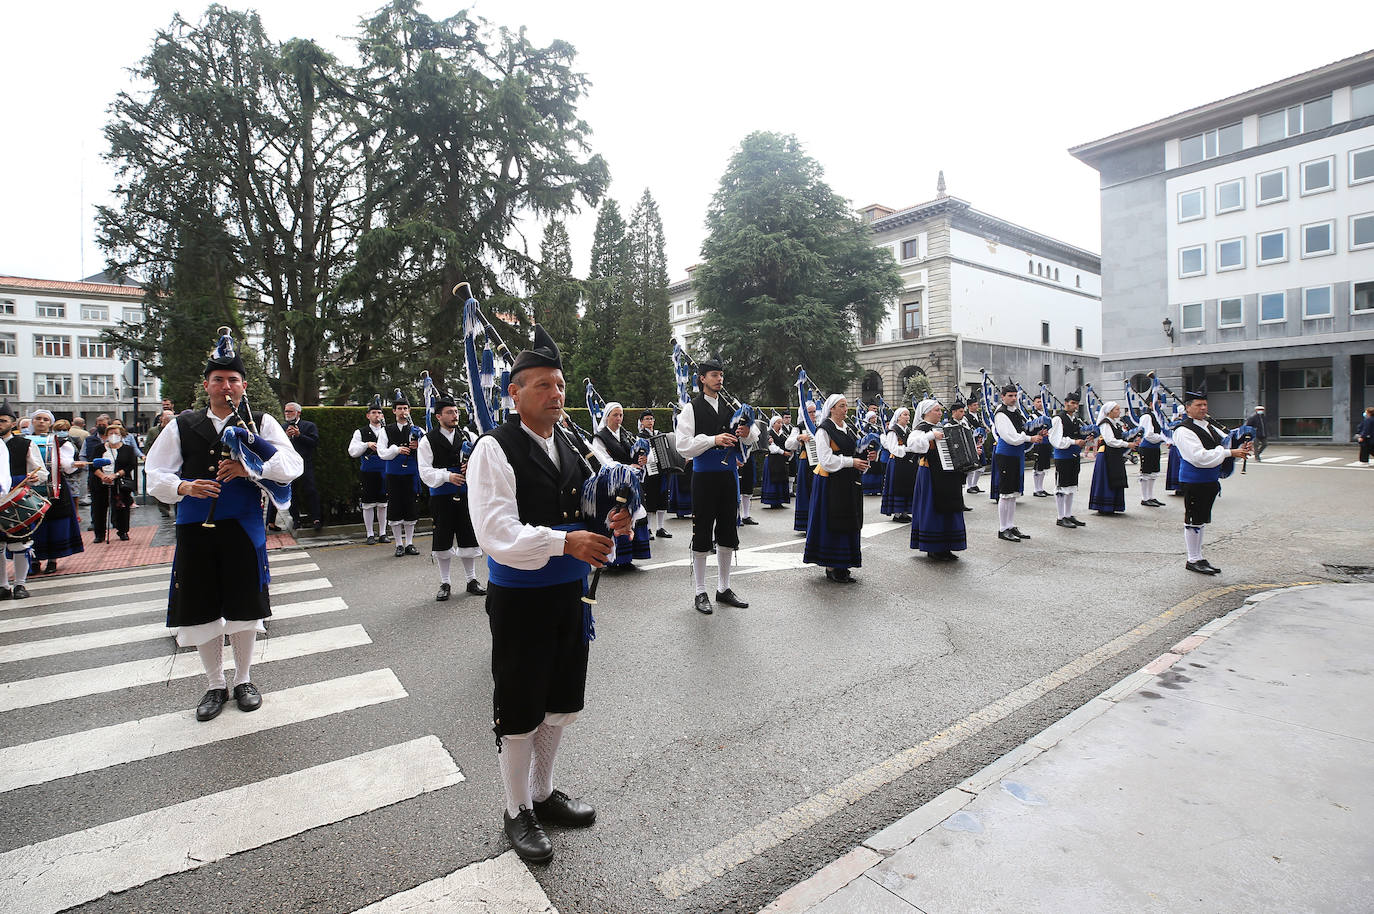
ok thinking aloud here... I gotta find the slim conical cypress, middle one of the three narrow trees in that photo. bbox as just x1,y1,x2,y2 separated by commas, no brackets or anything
573,199,629,384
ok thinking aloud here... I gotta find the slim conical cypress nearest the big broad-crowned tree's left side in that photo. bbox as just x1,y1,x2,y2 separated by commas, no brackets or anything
610,187,673,407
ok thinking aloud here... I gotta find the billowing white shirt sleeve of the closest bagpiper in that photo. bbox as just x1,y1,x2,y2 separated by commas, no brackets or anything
467,437,567,572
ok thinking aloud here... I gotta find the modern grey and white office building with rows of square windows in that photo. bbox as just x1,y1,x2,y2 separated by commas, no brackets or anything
1070,51,1374,441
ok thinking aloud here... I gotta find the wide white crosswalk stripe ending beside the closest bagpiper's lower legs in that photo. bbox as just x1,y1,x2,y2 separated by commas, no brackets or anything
0,735,463,914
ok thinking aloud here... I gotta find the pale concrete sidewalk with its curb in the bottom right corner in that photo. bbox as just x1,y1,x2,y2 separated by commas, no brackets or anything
764,584,1374,914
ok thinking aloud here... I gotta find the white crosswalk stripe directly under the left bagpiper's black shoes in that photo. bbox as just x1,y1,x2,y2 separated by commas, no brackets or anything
0,669,407,793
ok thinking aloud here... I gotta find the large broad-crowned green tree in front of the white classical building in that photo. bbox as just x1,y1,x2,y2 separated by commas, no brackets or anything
692,132,901,403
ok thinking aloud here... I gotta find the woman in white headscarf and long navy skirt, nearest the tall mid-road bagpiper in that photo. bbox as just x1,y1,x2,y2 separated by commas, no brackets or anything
802,393,871,584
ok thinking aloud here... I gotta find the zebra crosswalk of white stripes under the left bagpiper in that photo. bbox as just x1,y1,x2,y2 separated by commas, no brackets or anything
0,551,552,914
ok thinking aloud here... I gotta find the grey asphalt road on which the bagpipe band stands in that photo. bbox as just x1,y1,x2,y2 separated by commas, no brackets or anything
0,448,1374,914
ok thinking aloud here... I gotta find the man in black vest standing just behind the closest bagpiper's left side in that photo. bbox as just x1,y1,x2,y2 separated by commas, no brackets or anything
415,397,486,603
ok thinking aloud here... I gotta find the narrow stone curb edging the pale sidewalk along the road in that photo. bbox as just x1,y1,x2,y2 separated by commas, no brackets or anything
758,581,1320,914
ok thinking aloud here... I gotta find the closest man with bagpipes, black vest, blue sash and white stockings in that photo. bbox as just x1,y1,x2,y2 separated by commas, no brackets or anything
467,324,631,862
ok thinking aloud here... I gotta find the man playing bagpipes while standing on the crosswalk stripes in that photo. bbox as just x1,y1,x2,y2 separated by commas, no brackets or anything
144,330,301,722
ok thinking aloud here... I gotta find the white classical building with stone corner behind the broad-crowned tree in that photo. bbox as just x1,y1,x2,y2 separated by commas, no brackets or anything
668,175,1102,404
